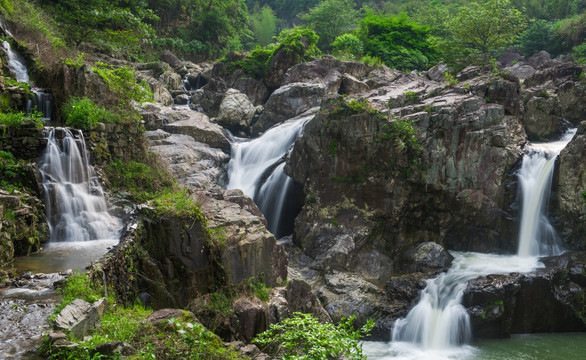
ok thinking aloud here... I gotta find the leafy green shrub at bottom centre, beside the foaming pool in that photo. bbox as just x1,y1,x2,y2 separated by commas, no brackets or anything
253,312,374,360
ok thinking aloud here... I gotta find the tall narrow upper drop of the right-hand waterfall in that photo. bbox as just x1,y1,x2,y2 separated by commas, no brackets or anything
517,129,576,256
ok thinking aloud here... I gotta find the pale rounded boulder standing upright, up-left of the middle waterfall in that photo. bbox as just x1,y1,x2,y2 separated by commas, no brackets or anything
216,89,256,132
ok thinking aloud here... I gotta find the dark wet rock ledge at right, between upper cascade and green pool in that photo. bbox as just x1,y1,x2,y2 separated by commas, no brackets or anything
462,253,586,338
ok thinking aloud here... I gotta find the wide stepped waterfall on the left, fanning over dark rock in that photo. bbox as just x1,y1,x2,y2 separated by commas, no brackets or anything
40,128,121,242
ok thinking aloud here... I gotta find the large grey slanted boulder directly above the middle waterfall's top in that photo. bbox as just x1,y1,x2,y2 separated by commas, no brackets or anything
253,83,326,132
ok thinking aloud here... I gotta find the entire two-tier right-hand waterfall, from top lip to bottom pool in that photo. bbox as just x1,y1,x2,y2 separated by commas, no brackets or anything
383,129,576,358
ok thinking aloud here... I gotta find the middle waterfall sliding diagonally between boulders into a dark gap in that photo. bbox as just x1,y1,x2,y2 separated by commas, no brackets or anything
228,113,314,237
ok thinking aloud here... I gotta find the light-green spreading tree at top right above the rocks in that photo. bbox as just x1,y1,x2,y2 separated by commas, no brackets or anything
450,0,526,64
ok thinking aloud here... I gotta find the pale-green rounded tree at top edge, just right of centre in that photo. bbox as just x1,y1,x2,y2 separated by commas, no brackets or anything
300,0,358,50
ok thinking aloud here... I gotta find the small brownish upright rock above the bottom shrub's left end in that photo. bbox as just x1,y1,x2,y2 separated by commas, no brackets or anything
232,298,268,342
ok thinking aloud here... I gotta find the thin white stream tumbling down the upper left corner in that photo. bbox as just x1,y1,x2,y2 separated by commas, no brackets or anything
2,41,52,121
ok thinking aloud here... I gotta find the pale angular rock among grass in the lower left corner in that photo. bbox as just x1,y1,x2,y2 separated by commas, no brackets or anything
55,299,99,338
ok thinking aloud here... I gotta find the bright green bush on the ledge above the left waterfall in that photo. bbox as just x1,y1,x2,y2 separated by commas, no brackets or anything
61,97,122,130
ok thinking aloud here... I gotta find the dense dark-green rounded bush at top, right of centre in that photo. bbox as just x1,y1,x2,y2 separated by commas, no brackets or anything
356,11,437,70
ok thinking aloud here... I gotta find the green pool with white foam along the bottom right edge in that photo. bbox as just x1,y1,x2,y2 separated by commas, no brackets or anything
364,333,586,360
